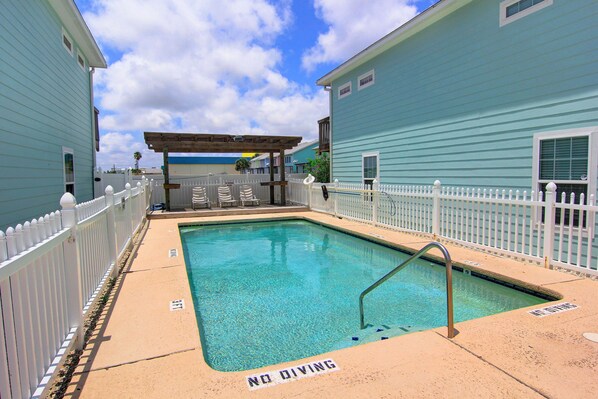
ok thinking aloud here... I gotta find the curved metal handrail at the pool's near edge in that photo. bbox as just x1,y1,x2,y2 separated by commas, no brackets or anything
359,241,455,338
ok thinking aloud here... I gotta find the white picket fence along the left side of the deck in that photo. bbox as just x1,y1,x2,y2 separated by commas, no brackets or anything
0,180,151,399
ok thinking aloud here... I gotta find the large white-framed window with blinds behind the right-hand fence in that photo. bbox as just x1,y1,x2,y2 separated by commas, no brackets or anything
533,128,598,226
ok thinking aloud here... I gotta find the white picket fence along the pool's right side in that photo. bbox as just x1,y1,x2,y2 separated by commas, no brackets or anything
289,180,598,275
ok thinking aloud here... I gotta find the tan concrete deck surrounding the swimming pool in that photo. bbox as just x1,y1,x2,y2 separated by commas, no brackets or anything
65,212,598,399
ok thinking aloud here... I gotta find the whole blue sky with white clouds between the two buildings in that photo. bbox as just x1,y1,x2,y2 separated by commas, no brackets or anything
75,0,436,170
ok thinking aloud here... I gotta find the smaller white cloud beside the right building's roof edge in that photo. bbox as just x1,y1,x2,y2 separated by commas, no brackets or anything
302,0,417,71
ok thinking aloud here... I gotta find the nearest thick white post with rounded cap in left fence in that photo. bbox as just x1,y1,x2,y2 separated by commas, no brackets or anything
60,193,84,349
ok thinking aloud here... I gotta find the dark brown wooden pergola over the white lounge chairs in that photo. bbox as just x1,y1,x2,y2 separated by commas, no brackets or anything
143,132,302,211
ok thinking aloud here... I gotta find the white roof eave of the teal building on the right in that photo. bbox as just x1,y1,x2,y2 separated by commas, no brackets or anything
316,0,473,86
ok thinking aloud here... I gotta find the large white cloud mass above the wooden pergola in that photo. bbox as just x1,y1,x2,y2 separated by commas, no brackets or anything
84,0,328,167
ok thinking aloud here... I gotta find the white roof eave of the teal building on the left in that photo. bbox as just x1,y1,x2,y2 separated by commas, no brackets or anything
49,0,108,68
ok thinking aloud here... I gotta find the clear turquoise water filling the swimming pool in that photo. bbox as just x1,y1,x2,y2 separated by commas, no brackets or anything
180,221,546,371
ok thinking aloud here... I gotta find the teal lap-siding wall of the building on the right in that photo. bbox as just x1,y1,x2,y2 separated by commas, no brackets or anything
331,0,598,190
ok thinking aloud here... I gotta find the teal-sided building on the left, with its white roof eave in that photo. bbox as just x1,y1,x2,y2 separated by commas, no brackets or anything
0,0,106,230
